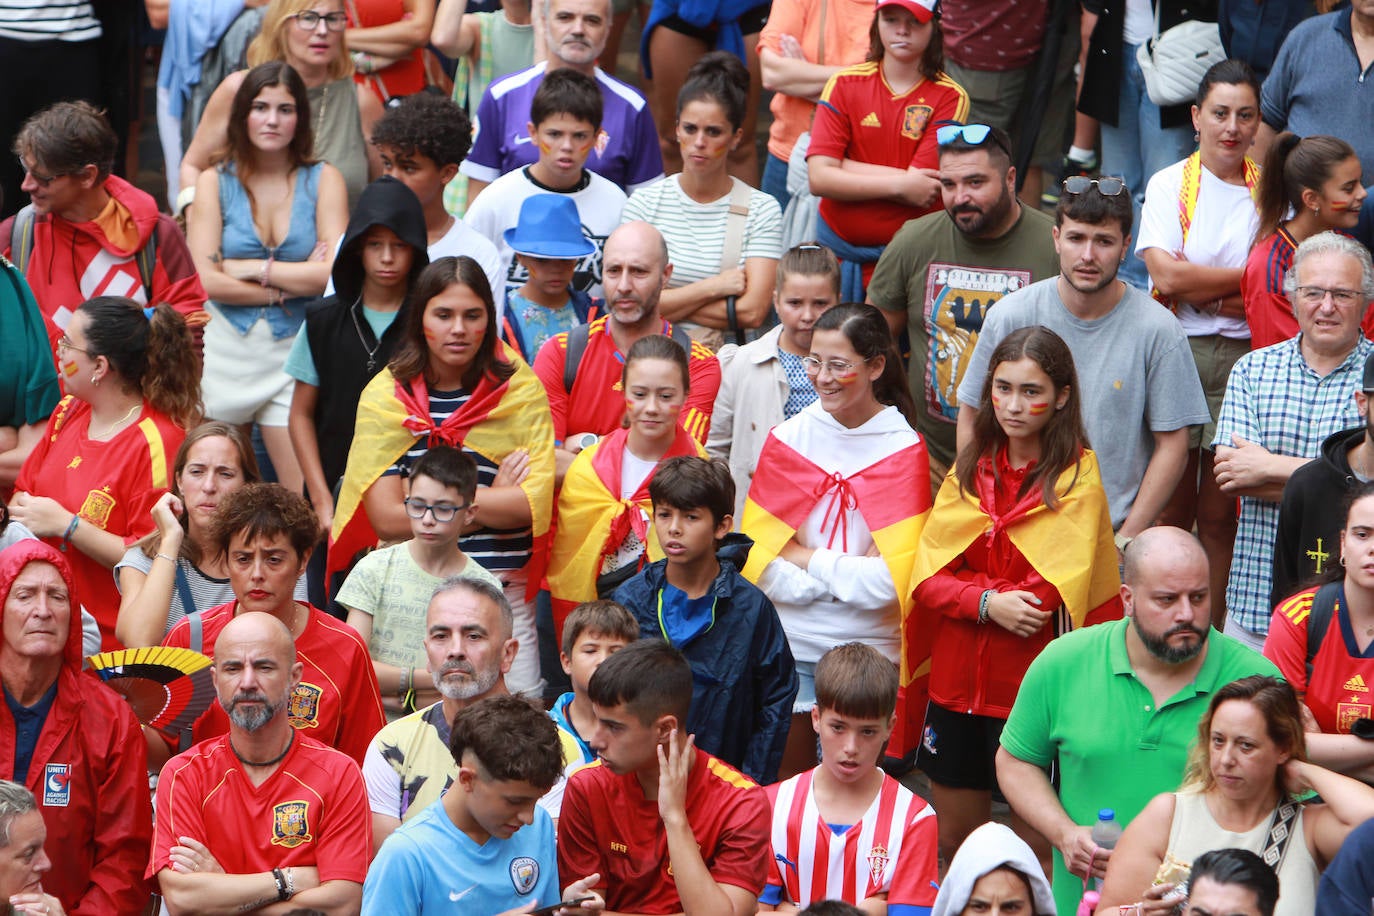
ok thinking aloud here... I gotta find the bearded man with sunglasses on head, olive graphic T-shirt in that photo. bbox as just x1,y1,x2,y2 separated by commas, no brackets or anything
868,124,1059,490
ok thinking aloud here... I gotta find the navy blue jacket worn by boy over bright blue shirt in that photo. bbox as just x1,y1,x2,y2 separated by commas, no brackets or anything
616,533,797,786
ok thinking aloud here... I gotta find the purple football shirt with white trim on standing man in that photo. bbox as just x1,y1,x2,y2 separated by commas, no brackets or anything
460,63,664,194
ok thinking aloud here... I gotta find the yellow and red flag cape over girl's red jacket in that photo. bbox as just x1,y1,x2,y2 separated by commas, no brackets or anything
905,449,1121,658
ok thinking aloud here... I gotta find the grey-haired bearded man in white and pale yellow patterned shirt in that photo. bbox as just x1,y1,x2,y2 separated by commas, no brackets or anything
363,577,519,850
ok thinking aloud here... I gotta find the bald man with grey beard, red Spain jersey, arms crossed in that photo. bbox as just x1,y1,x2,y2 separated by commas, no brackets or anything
147,611,372,913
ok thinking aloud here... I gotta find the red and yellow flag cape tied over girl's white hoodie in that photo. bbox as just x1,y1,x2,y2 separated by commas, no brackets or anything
739,404,930,748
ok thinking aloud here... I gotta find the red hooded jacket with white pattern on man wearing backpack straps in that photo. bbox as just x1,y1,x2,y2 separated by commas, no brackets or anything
0,174,206,346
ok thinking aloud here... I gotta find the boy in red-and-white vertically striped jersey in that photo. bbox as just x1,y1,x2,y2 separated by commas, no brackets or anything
758,643,940,916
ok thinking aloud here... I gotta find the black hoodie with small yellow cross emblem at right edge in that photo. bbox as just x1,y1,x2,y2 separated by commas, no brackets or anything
1270,426,1364,607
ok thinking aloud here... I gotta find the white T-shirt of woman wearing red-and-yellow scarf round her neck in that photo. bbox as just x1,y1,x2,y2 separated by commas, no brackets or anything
1135,159,1260,341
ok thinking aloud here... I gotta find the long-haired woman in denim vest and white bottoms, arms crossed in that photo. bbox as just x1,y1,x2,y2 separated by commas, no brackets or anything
187,60,348,492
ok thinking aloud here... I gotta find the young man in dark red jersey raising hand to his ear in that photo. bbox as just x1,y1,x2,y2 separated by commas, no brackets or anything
558,640,768,916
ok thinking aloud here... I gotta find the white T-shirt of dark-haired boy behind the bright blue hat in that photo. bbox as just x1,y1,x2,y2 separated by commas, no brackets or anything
463,166,625,302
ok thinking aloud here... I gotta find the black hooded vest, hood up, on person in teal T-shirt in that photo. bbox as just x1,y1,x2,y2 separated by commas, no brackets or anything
305,177,429,489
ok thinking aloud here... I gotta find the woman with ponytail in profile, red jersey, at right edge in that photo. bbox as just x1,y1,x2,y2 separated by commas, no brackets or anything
1241,130,1374,350
